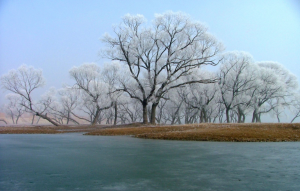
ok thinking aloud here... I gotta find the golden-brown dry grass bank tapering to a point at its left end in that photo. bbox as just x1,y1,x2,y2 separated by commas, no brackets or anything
87,123,300,142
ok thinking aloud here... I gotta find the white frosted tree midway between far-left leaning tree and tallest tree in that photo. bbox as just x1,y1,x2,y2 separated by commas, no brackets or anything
69,63,112,125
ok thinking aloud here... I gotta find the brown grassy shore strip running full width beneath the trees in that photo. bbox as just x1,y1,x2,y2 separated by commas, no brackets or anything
0,123,300,142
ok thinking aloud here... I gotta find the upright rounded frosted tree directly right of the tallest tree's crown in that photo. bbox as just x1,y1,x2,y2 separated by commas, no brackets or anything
219,51,256,123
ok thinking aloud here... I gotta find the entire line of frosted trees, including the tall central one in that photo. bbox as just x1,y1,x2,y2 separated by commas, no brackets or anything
0,12,300,125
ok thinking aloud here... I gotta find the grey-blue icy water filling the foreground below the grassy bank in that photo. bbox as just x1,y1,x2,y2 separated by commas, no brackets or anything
0,133,300,191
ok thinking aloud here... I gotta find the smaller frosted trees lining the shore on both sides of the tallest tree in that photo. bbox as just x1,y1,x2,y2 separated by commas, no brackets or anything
1,52,300,125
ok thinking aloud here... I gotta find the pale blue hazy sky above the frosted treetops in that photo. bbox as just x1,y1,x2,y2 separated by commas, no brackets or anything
0,0,300,115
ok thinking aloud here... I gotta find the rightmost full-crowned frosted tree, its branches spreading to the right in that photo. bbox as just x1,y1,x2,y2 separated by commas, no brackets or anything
252,62,298,122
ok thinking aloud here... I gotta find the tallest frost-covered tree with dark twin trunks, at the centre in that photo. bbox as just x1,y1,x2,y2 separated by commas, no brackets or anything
101,12,222,123
